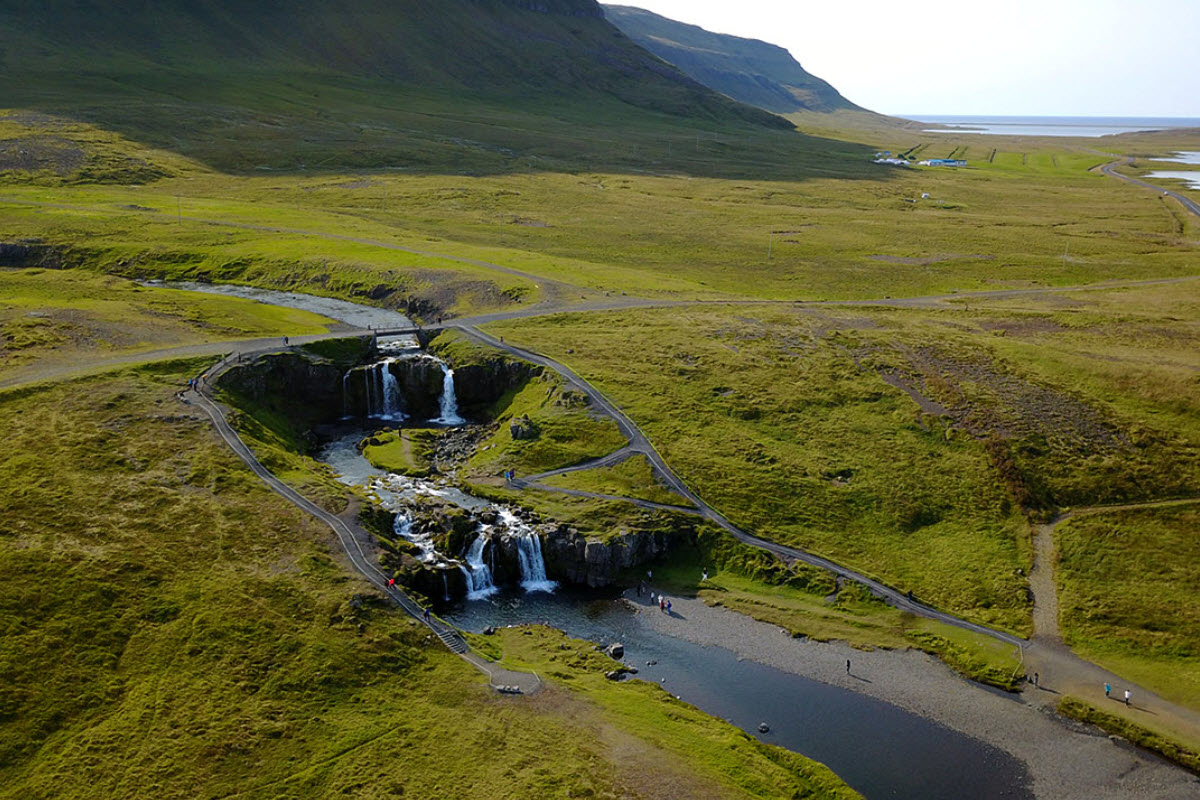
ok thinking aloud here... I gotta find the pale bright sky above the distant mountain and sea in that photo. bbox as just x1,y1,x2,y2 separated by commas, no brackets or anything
609,0,1200,118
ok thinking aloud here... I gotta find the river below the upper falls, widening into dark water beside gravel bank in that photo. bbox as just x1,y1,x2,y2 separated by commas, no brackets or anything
322,433,1033,800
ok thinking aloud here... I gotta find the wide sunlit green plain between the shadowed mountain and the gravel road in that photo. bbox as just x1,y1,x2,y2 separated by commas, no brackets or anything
0,107,1195,314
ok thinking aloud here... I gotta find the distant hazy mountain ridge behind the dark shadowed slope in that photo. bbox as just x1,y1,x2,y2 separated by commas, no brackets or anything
604,6,862,114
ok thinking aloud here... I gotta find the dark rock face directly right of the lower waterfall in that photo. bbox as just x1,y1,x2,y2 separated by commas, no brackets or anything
542,527,695,588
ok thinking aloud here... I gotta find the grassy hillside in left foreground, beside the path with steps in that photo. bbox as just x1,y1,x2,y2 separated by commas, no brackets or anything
0,362,854,800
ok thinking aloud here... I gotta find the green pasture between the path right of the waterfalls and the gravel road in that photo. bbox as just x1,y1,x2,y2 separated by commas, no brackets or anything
492,282,1200,630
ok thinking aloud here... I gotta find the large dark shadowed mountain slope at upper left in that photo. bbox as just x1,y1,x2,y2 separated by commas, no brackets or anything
0,0,806,170
